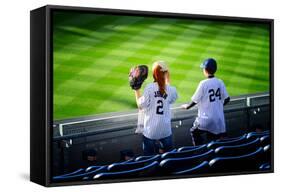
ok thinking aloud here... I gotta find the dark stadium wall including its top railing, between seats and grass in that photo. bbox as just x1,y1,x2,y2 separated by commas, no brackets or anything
52,93,270,175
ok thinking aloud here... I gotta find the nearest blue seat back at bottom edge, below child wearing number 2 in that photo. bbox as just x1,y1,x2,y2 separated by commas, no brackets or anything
93,161,159,179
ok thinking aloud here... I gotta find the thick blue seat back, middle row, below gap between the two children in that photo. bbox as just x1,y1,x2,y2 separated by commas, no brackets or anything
160,149,214,173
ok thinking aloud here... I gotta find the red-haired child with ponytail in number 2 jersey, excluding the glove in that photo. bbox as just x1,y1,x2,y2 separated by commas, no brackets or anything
135,61,178,155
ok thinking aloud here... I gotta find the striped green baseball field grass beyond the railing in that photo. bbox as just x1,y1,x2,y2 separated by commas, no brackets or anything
53,12,270,120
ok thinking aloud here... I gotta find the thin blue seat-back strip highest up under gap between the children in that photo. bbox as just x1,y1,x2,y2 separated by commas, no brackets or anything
161,145,208,159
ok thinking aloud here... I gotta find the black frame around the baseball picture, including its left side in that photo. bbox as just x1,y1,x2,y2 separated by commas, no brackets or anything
30,5,274,186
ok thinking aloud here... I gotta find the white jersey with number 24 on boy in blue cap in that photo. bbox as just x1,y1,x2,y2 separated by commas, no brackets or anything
191,77,228,134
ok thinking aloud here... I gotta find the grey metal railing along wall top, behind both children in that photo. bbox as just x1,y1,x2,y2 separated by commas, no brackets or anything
53,92,270,141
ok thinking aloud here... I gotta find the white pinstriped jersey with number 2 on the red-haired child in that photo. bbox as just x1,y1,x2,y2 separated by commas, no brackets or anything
138,83,178,139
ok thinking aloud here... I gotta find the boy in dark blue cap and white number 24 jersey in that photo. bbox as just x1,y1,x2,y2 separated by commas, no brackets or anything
182,58,230,145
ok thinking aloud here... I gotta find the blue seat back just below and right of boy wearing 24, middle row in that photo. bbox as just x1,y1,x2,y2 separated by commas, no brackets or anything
215,138,260,157
